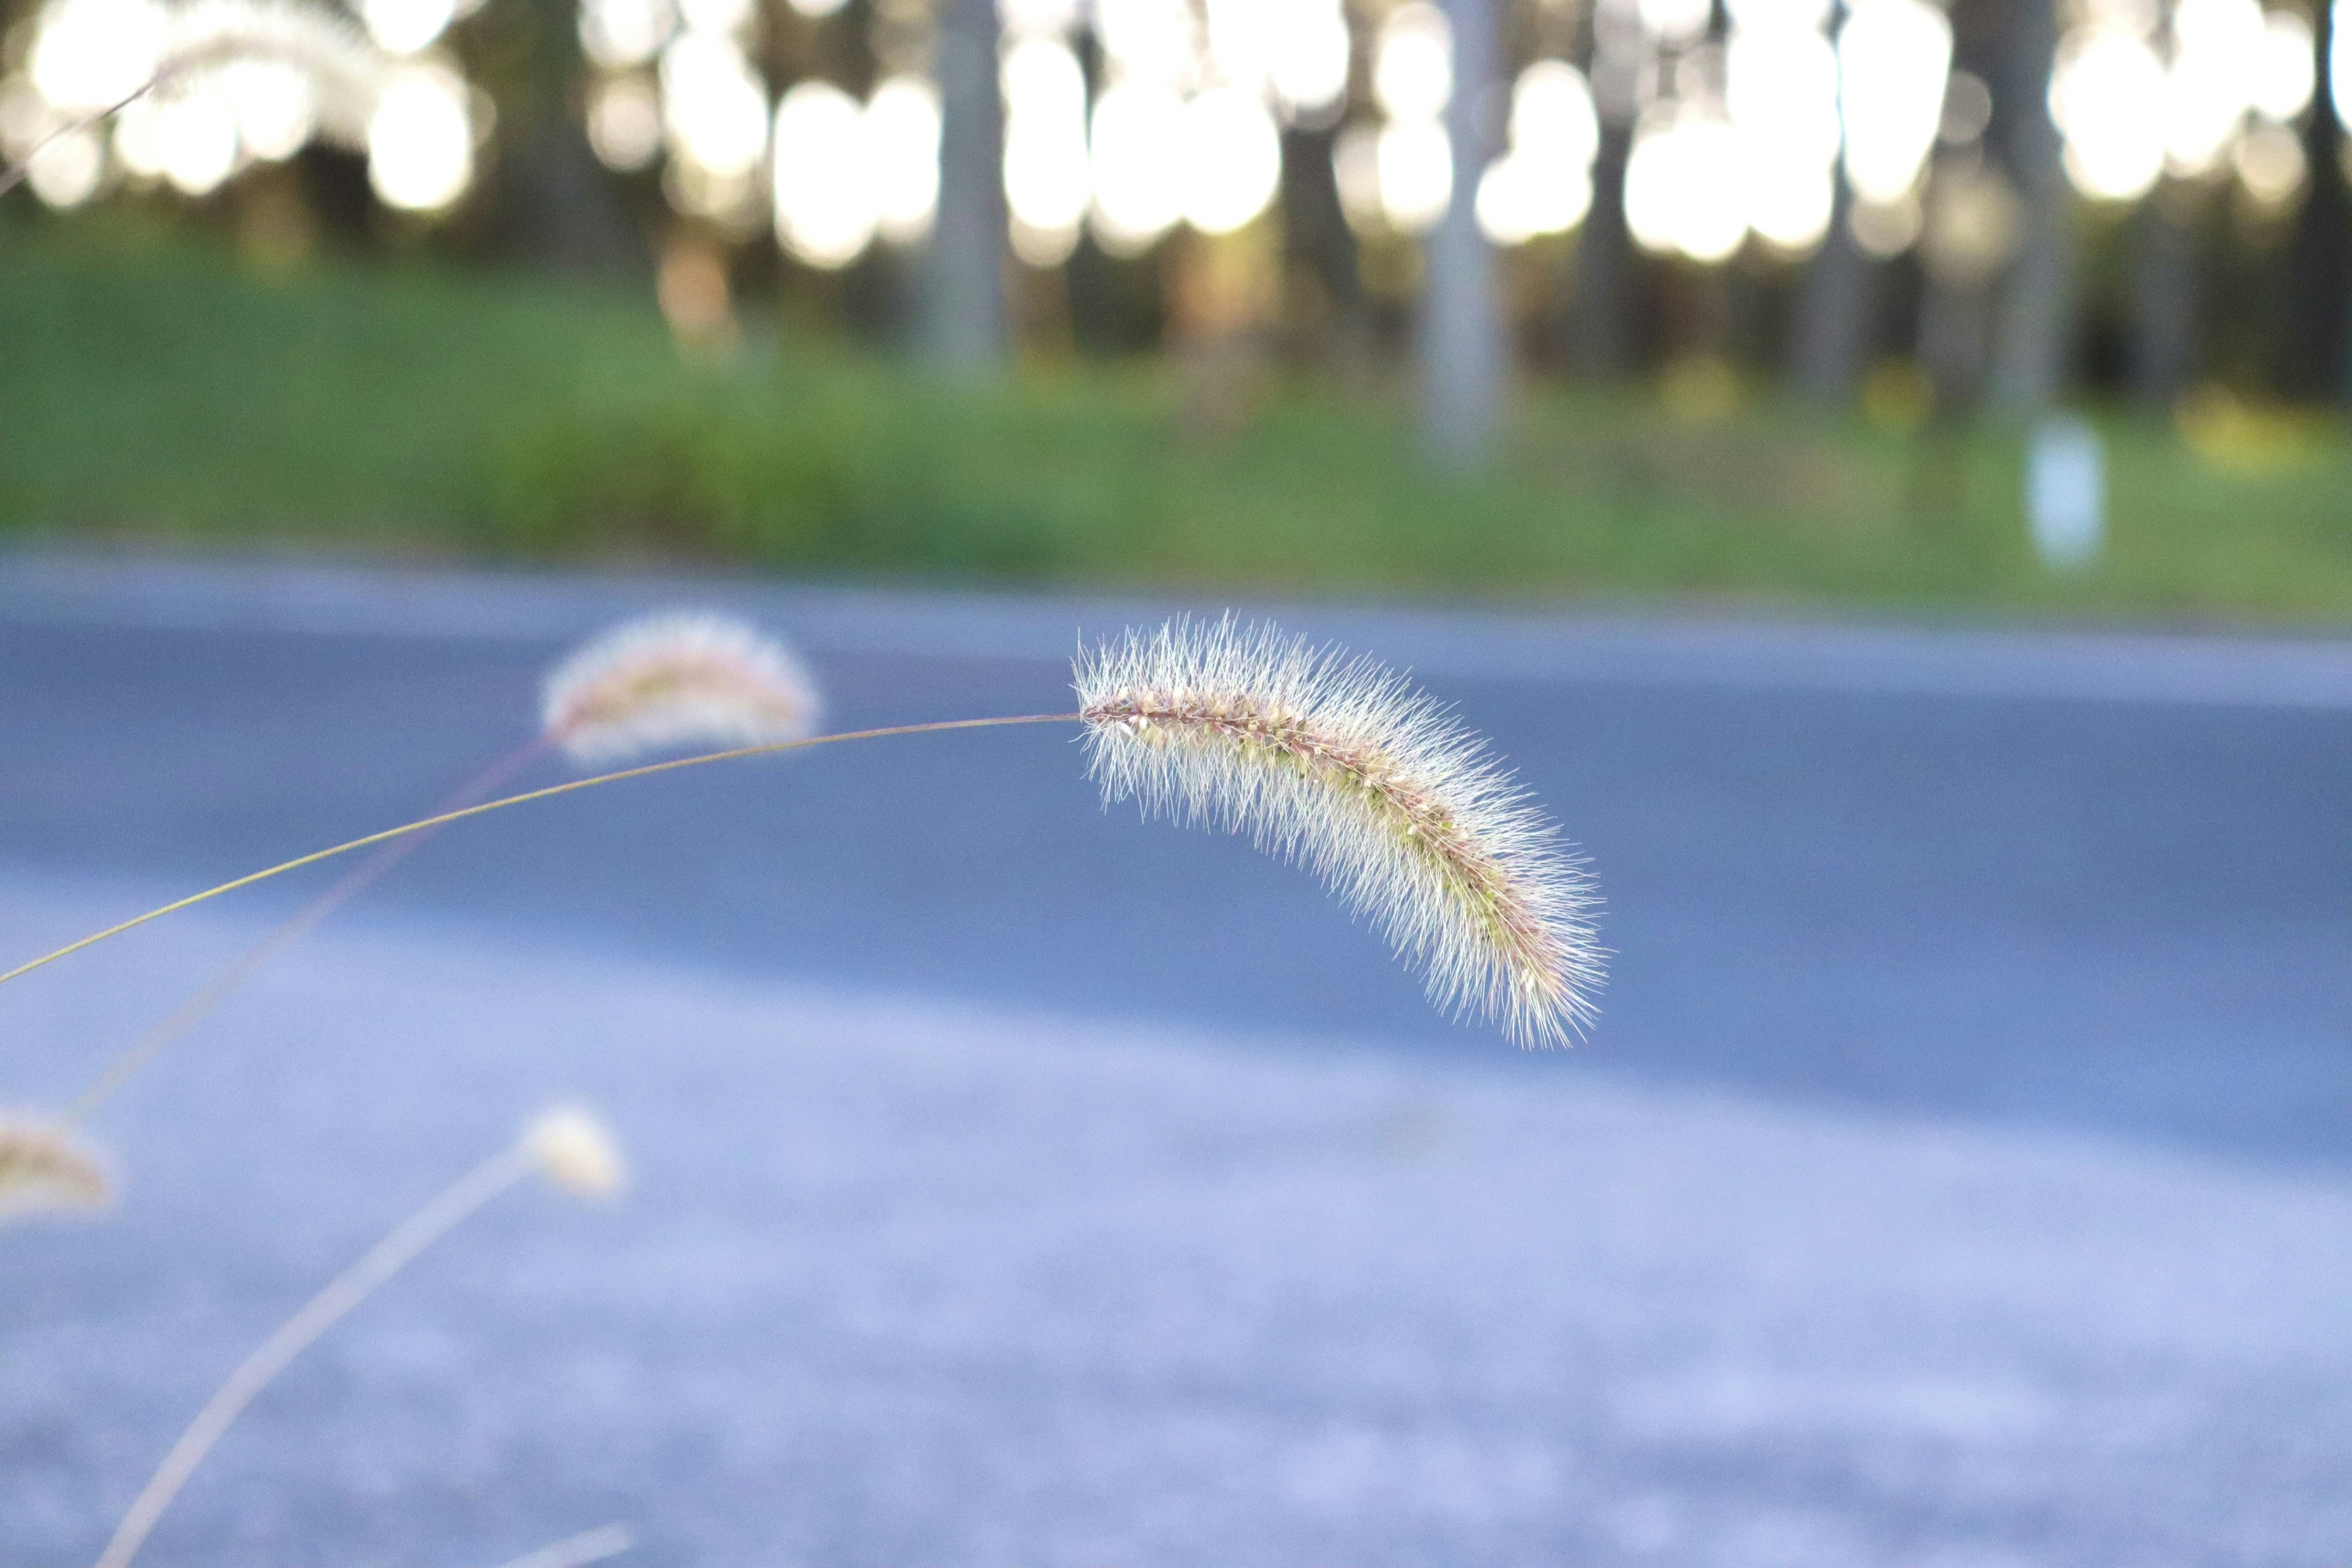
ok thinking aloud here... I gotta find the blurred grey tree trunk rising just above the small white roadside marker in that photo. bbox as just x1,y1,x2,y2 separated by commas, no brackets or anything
1990,0,2075,414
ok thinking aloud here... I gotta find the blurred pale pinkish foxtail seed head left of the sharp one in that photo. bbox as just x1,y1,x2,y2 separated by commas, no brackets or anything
541,614,823,764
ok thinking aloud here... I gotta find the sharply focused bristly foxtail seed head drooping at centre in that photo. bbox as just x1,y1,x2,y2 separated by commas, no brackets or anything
1077,616,1604,1046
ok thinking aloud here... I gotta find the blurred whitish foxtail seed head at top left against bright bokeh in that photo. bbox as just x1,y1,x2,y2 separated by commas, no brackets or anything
155,0,395,151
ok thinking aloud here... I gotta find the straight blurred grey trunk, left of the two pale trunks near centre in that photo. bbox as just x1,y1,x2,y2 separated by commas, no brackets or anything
919,0,1005,371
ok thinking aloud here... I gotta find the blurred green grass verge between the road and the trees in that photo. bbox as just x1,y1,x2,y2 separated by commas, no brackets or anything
0,224,2352,623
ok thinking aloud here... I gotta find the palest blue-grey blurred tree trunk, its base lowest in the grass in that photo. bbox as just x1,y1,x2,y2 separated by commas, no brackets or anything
1420,0,1507,463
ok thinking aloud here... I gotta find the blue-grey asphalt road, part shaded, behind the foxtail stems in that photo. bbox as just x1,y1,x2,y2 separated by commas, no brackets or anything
0,559,2352,1568
